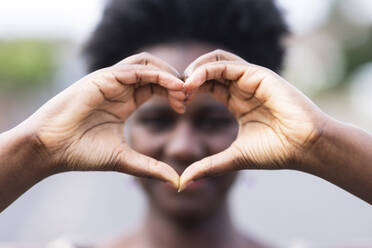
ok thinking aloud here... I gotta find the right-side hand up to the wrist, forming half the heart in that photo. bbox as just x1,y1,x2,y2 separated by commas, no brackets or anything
179,50,327,190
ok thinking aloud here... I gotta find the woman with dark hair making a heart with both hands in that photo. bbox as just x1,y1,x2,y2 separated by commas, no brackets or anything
0,0,372,248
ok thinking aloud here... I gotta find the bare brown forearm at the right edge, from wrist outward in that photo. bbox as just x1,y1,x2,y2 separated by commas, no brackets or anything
304,117,372,204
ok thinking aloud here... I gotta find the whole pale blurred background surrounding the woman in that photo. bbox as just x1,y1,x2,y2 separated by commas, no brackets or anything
0,0,372,248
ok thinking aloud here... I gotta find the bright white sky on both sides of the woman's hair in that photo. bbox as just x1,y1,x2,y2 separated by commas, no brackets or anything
0,0,338,41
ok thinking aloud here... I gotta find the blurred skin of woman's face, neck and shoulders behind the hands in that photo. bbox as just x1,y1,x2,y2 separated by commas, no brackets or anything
112,43,263,248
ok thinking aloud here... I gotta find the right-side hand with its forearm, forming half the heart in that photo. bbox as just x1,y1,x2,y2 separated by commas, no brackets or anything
180,50,372,203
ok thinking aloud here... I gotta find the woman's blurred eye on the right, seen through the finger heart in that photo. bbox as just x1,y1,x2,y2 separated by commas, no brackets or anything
195,115,233,133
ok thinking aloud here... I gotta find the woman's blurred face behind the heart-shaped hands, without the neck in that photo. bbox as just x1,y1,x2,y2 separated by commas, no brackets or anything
129,43,238,217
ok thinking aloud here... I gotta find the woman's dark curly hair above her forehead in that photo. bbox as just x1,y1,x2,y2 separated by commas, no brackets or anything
84,0,287,71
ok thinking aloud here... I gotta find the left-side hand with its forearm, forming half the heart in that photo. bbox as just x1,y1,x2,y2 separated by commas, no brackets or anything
0,53,185,210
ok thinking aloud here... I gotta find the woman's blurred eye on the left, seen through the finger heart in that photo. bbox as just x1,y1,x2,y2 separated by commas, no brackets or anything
138,113,176,132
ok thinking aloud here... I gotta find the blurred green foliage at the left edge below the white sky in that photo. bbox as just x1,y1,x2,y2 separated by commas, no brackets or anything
0,40,55,90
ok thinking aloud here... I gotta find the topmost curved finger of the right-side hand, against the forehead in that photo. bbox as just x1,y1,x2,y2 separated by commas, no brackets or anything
184,49,248,79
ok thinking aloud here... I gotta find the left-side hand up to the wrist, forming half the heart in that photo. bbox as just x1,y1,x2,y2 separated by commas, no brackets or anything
24,53,185,188
